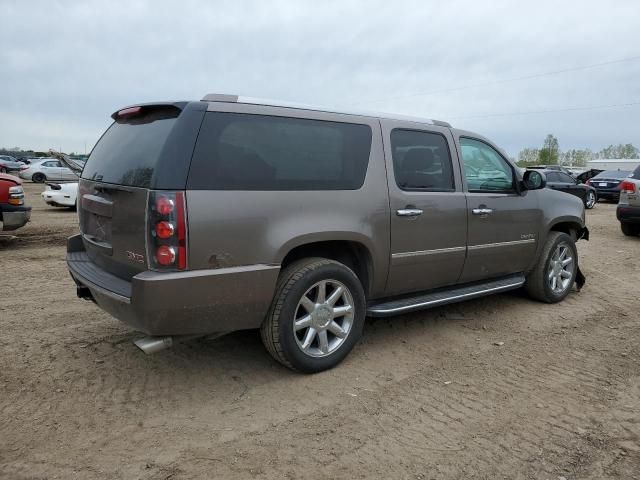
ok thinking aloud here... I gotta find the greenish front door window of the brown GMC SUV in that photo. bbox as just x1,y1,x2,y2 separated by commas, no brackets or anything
460,137,514,193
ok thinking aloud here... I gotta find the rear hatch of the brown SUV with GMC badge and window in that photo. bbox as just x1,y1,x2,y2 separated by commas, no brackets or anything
78,102,206,280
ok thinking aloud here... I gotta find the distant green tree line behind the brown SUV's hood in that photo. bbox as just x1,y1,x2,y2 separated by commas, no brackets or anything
516,134,640,167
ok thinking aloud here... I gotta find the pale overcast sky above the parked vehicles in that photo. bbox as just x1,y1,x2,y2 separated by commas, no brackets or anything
0,0,640,156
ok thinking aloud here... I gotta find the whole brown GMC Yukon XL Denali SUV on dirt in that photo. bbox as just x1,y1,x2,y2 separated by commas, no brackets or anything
67,95,588,372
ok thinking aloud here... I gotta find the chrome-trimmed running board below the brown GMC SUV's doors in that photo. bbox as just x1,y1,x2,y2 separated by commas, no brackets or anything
367,274,525,317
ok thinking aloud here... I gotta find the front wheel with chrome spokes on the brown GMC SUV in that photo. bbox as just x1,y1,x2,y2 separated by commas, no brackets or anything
525,232,578,303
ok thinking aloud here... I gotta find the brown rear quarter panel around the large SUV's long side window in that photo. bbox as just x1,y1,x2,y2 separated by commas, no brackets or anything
187,103,390,296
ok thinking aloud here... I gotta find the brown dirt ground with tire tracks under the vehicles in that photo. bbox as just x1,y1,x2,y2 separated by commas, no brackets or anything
0,184,640,480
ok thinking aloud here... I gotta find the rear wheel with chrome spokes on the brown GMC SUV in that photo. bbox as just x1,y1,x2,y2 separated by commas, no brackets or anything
260,258,366,373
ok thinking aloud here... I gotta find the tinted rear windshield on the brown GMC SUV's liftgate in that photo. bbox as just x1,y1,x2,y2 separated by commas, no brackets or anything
82,107,180,188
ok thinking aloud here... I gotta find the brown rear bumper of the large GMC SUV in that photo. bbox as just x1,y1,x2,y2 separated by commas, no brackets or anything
67,235,280,335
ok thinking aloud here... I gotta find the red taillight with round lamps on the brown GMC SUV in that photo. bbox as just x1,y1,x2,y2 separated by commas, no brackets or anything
147,191,187,270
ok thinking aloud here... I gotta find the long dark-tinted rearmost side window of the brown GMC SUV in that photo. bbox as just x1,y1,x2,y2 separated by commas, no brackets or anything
189,112,371,190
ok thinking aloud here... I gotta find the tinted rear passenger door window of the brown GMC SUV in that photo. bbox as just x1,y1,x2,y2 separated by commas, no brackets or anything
391,129,455,192
